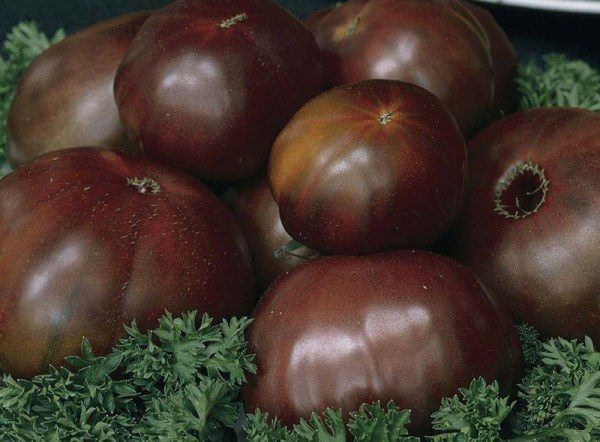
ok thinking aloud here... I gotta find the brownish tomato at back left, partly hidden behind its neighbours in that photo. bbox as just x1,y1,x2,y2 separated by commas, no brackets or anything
7,12,150,166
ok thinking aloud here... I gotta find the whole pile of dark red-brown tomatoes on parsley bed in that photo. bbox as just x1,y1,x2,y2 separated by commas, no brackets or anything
0,0,600,432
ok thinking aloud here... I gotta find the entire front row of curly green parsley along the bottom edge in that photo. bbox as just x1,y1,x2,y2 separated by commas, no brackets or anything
0,313,600,442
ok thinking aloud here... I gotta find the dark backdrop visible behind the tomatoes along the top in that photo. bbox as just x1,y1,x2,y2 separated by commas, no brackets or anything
0,0,600,68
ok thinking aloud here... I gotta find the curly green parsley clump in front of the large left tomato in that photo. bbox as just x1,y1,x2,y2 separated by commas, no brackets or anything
0,313,256,441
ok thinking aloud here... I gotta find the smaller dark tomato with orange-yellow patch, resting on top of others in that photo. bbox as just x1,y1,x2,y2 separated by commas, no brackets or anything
269,80,466,254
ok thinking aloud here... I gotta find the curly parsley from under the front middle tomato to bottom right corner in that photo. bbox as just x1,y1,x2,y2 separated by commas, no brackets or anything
246,327,600,442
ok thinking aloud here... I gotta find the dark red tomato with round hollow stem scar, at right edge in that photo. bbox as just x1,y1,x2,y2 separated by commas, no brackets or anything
454,108,600,342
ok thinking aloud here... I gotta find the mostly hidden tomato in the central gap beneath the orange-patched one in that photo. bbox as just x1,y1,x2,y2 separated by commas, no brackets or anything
225,178,316,290
